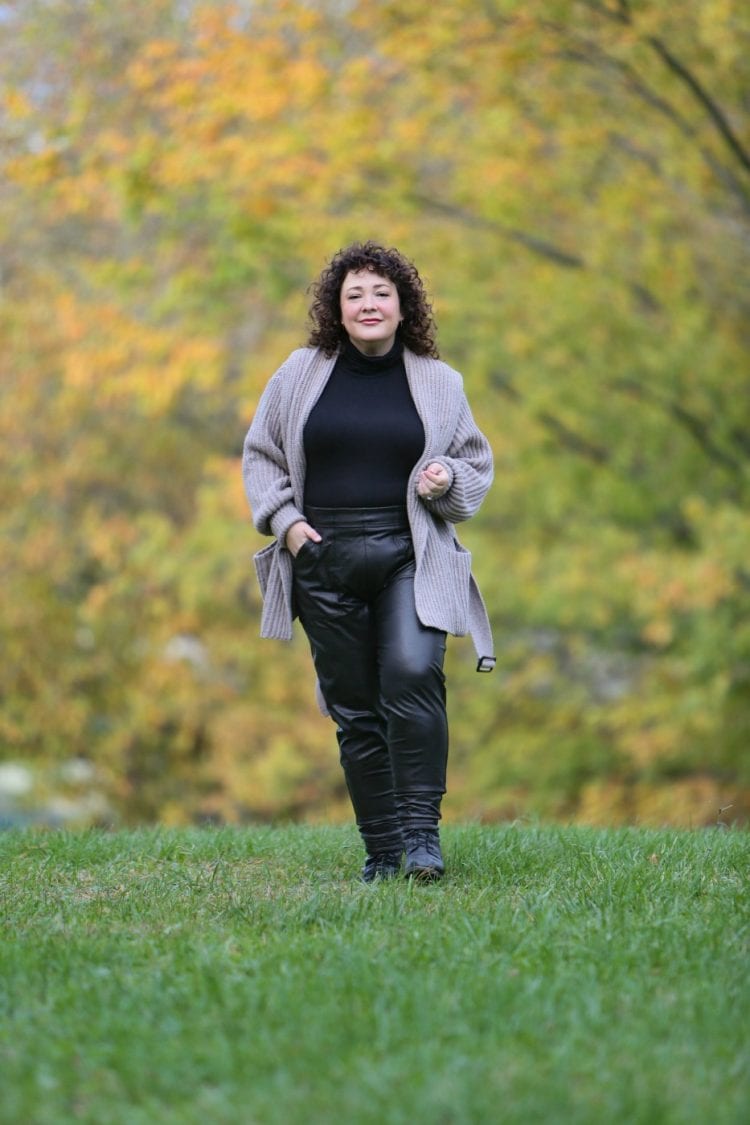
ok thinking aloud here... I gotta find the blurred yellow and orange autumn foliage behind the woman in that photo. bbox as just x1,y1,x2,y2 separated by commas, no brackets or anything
0,0,750,824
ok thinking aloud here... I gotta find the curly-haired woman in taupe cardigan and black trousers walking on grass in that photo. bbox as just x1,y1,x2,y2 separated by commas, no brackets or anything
243,242,495,882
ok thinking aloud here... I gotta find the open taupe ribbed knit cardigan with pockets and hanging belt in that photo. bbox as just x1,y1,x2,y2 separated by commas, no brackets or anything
243,348,494,671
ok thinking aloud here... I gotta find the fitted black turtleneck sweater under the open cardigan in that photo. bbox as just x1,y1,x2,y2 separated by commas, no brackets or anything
304,340,424,507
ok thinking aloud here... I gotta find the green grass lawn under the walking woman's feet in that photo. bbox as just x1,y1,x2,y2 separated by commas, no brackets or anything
0,826,750,1125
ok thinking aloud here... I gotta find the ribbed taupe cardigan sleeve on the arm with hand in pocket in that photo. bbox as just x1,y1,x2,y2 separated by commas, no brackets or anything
242,356,305,542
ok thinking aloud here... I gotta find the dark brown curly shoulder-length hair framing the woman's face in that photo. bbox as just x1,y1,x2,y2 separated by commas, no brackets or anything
307,242,439,359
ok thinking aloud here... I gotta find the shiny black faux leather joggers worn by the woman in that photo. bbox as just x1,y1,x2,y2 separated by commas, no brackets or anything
293,507,448,855
